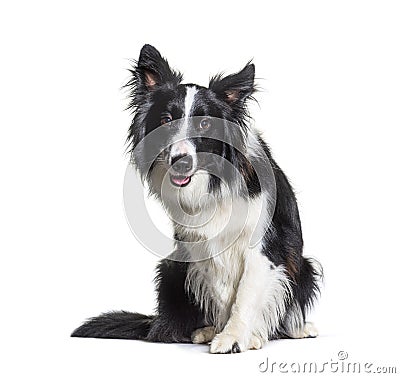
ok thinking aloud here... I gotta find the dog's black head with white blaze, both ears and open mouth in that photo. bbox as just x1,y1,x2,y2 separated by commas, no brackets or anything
128,45,255,208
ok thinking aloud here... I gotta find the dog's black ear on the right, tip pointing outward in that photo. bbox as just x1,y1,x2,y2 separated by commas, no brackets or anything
209,63,256,106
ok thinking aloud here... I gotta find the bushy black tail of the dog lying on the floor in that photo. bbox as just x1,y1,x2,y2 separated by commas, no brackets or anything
71,311,155,340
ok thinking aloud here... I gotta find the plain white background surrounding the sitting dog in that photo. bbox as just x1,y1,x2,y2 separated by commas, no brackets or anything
0,0,400,378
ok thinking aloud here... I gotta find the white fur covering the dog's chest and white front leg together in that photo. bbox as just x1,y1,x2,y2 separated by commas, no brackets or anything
180,196,290,353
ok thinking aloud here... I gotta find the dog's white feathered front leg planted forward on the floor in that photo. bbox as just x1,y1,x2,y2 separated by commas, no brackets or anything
210,250,288,353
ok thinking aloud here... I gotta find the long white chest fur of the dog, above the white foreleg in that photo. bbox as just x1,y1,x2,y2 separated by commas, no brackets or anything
178,197,262,329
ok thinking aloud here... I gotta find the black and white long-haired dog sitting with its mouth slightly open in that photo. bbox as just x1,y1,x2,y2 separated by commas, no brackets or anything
72,45,322,353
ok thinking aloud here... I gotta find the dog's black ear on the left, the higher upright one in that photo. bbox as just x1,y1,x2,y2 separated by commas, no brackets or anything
136,45,182,91
